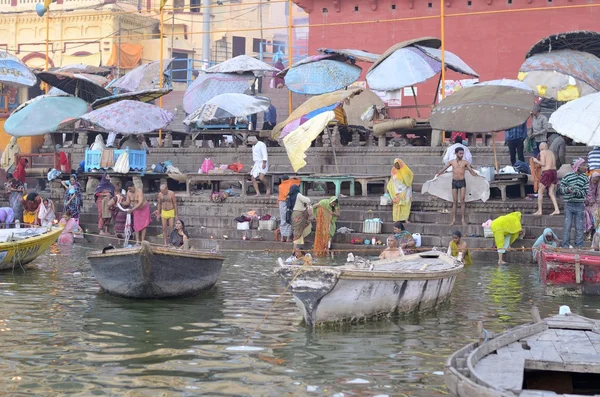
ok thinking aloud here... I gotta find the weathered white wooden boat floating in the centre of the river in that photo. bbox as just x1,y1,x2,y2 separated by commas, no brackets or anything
275,251,463,327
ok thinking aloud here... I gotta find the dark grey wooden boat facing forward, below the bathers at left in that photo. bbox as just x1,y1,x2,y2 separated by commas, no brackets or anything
88,242,225,299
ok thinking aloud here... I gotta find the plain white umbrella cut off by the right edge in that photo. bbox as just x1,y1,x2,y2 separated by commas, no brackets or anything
550,93,600,146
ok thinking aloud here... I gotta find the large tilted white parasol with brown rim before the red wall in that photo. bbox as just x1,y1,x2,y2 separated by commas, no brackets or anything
367,45,479,91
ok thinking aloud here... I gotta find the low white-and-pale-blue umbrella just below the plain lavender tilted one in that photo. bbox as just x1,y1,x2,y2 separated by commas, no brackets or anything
183,94,271,125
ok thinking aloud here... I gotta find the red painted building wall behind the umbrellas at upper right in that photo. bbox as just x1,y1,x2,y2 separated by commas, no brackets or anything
295,0,600,117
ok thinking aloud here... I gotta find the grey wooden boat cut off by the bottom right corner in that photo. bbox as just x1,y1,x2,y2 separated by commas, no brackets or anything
444,306,600,397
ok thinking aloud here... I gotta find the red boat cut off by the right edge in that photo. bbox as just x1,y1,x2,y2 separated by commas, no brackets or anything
538,245,600,295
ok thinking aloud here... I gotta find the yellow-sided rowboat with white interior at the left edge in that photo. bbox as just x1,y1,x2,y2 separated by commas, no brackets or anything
0,227,62,270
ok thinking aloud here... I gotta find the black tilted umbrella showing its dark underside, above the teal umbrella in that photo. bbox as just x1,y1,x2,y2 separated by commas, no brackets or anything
37,72,111,103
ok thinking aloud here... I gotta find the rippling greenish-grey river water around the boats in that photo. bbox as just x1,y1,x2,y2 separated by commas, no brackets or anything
0,246,600,397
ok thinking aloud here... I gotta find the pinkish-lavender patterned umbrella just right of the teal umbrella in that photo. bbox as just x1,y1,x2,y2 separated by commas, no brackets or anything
81,100,174,135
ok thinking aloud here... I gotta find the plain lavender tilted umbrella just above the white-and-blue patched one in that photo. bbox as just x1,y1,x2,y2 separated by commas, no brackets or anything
183,73,254,114
